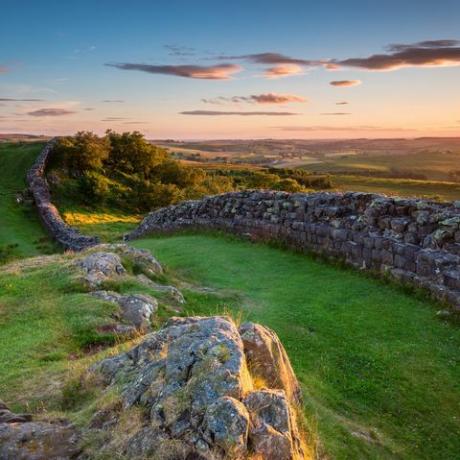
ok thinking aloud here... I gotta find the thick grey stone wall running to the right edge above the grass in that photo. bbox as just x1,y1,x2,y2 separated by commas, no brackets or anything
126,191,460,310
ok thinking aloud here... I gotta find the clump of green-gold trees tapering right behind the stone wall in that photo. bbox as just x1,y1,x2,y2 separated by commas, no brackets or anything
48,130,331,212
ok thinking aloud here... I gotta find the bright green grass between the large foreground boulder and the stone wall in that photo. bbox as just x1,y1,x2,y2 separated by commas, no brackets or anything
135,235,460,459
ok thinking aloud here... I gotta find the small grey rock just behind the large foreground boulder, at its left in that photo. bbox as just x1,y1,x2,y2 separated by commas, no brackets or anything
92,291,158,331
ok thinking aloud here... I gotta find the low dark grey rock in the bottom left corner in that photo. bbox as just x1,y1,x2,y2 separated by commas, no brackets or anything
0,401,81,460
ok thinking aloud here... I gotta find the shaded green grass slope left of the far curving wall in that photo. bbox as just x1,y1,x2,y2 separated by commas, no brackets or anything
0,143,53,263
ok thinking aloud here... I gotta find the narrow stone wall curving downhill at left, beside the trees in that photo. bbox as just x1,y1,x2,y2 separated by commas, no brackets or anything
27,140,99,251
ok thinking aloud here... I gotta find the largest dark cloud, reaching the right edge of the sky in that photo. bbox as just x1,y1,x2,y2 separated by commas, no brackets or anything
333,39,460,70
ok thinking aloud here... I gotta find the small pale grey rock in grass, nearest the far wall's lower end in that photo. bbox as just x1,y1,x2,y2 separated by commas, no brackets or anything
77,252,126,288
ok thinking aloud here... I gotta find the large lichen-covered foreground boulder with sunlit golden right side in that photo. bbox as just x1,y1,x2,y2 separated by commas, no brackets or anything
91,317,307,460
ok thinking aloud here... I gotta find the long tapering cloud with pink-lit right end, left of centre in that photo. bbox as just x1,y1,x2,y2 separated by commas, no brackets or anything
105,63,243,80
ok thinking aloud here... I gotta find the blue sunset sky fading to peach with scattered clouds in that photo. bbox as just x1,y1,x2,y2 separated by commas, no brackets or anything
0,0,460,140
